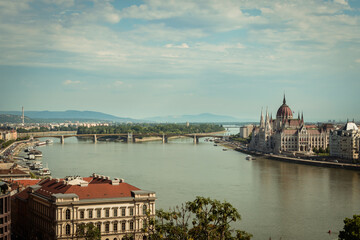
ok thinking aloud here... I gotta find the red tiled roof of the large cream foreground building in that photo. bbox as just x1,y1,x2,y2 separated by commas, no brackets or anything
36,177,140,199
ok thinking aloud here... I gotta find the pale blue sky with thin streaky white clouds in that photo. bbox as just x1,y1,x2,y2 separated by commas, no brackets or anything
0,0,360,121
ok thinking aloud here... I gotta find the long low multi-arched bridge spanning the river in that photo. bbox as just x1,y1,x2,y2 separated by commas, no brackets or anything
18,131,224,144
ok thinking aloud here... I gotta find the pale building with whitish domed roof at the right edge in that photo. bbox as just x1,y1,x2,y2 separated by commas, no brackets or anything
330,122,360,160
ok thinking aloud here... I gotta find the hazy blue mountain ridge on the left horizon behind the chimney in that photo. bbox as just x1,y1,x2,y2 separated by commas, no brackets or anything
0,110,139,122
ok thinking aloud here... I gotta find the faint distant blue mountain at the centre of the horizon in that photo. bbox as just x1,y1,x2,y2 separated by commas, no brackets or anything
146,113,239,123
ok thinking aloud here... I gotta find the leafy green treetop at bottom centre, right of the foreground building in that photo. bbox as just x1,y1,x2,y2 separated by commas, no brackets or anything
143,197,252,240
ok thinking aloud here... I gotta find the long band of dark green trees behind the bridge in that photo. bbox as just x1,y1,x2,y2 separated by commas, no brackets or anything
78,124,225,134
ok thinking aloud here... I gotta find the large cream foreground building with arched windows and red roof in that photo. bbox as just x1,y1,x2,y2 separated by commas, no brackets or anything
13,174,156,240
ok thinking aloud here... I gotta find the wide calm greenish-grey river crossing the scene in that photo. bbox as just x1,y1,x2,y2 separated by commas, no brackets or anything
35,131,360,240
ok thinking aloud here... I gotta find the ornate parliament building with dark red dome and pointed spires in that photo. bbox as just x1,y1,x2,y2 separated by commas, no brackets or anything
249,95,333,153
